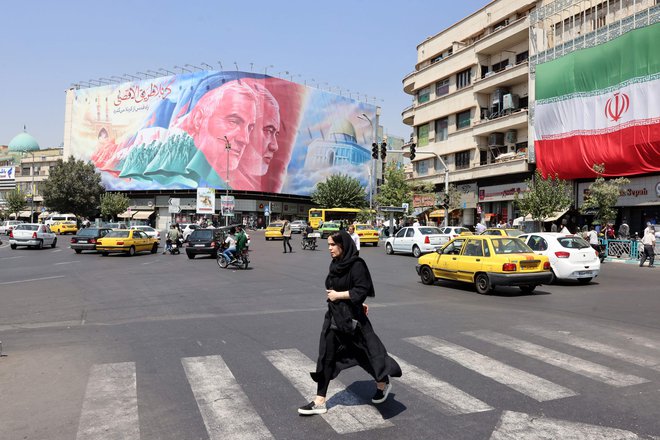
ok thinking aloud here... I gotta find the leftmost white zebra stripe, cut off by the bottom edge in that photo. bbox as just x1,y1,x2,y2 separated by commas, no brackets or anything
76,362,140,440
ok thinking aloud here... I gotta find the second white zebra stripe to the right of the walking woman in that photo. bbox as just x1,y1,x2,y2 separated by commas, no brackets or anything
404,336,577,402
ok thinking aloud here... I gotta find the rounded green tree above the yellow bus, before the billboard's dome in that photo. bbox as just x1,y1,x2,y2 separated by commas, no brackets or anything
312,174,367,208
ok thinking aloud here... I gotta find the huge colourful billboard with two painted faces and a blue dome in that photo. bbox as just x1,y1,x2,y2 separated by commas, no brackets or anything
65,71,376,195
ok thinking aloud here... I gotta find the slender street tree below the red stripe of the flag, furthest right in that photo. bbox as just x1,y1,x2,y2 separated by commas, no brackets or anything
580,164,630,225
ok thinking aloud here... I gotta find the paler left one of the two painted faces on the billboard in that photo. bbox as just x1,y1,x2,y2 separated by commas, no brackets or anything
191,83,257,175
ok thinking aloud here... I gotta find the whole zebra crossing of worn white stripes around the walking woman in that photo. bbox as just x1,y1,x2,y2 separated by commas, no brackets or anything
76,325,660,440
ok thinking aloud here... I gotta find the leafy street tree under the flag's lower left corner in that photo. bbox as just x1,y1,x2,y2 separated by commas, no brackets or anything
514,170,572,229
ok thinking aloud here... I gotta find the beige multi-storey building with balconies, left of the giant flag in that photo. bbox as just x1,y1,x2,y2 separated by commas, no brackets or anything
402,0,536,225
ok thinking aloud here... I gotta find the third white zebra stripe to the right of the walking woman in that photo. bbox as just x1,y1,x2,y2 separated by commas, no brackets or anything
463,330,648,387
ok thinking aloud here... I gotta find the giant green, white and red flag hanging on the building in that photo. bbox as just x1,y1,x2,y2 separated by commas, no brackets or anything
534,23,660,179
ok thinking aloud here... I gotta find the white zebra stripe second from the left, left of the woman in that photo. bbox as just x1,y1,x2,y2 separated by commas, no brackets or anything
181,356,274,440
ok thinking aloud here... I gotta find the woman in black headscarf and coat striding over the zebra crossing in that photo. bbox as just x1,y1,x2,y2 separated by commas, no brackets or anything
298,231,401,415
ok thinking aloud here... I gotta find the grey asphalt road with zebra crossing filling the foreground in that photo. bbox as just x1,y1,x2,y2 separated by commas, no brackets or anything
0,232,660,440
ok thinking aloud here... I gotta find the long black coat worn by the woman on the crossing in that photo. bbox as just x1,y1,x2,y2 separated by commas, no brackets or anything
311,254,401,382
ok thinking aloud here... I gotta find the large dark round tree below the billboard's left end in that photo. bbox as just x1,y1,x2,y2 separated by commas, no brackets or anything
42,156,105,217
